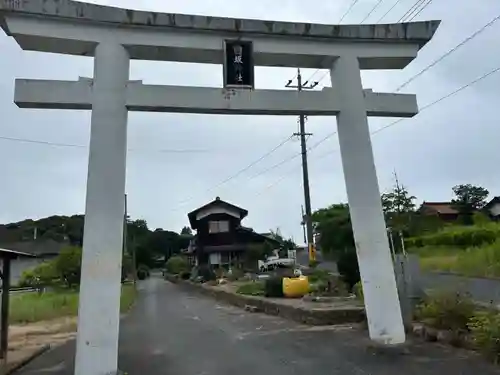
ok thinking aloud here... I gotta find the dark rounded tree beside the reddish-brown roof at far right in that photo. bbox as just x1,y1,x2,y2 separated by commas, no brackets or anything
451,184,490,225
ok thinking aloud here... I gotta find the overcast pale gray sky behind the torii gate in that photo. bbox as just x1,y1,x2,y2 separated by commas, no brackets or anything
0,0,500,242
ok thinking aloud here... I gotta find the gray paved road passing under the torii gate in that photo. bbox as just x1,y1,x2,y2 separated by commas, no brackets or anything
19,278,499,375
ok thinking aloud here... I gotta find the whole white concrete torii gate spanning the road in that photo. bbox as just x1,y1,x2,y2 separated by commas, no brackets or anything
0,0,439,375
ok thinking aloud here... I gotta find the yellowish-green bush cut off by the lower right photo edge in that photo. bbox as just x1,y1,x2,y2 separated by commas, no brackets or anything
468,311,500,363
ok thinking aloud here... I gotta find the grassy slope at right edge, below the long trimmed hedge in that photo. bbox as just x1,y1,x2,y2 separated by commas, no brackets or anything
412,241,500,277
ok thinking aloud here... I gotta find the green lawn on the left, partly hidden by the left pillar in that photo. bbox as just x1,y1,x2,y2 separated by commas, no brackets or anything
10,284,137,323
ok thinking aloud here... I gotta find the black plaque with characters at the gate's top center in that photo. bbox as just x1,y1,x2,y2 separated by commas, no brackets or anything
224,40,254,89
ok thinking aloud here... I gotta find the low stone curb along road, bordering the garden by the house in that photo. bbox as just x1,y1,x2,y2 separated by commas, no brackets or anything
165,275,365,326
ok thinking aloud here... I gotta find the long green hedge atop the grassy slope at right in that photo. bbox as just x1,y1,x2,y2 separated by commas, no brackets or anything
405,224,500,248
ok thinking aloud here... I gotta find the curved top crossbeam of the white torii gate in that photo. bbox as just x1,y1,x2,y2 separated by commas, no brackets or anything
0,0,439,69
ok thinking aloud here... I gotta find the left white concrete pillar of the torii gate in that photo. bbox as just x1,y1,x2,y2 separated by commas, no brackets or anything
75,43,130,375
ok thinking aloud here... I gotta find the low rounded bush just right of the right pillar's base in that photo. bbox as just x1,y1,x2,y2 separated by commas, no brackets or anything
415,292,475,331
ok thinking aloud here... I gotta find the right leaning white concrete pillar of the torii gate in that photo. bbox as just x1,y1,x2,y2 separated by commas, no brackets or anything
330,56,405,345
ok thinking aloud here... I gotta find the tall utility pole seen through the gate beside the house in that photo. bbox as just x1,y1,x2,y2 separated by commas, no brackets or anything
285,69,318,261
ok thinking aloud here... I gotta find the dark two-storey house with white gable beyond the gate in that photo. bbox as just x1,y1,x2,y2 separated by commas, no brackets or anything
187,197,280,267
